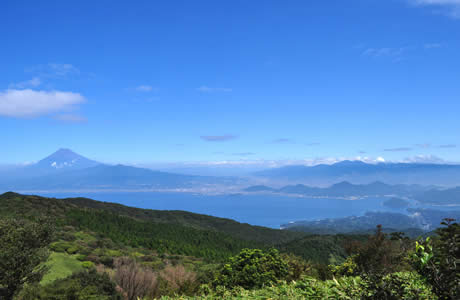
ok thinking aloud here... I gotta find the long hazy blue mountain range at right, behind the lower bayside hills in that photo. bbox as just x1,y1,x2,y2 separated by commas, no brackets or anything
253,161,460,186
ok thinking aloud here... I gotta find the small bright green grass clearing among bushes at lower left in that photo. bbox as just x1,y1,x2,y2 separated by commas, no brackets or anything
40,252,83,285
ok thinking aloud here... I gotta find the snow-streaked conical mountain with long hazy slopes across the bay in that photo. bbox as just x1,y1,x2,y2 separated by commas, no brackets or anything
0,149,243,190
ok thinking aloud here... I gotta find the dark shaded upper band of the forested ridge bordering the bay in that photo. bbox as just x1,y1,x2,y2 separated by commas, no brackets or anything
0,192,304,245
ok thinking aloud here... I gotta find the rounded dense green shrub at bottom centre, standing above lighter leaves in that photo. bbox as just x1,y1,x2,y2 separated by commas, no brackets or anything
214,249,289,289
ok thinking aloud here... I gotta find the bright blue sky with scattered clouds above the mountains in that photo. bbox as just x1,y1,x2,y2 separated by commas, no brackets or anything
0,0,460,164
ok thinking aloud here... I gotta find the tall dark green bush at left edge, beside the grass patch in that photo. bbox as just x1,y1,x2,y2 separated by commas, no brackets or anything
0,219,53,299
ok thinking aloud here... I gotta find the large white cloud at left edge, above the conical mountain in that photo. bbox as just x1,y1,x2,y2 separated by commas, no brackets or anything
0,89,85,118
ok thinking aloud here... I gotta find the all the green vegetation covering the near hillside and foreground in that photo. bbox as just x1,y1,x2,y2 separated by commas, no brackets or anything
0,193,460,300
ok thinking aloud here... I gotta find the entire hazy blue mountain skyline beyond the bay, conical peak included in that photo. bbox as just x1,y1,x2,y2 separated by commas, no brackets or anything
0,149,460,193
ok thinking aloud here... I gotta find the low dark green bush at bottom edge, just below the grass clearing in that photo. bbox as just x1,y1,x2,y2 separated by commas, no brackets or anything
21,269,122,300
